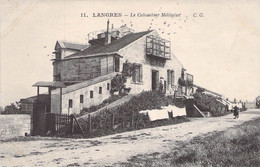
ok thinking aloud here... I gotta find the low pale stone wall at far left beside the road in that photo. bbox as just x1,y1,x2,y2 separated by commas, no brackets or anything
0,114,31,139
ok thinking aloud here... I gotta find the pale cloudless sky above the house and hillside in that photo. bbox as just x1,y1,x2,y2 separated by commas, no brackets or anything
0,0,260,106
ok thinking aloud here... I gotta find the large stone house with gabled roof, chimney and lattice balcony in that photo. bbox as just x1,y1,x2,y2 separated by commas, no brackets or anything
27,22,193,114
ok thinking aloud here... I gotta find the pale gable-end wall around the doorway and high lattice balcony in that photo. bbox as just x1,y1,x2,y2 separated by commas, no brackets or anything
119,31,183,94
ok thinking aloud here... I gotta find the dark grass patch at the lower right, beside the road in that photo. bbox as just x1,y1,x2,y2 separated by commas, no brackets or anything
117,118,260,167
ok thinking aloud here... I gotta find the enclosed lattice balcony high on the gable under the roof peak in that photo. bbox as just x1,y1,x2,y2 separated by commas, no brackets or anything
146,35,171,60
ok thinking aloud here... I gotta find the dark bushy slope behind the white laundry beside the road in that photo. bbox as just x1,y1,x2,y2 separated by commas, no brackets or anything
81,91,187,137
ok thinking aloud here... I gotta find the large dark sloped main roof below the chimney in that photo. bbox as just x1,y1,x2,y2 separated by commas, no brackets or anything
65,30,152,59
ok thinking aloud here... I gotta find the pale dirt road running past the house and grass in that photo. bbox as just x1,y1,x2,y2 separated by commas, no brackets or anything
0,110,260,167
